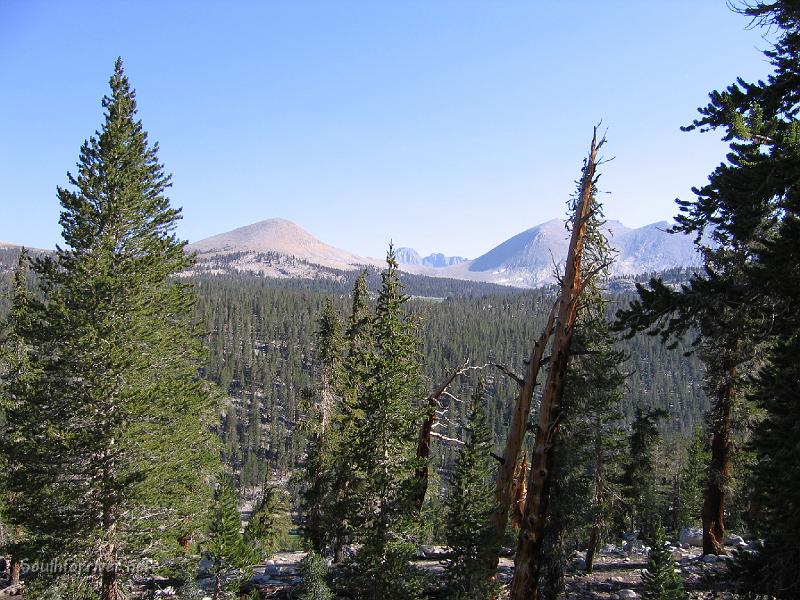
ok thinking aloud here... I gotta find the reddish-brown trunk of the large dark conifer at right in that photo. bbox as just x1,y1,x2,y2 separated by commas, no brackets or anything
702,369,736,555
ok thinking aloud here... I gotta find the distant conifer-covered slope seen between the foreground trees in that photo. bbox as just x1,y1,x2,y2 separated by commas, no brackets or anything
0,250,708,487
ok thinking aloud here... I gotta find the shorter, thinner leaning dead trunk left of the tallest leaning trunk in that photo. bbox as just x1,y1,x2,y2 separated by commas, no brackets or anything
491,304,557,568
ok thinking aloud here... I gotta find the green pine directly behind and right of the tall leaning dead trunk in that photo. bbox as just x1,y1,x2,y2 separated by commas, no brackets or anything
540,255,625,599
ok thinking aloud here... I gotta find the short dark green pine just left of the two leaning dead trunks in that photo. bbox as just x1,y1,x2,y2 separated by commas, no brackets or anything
445,380,499,600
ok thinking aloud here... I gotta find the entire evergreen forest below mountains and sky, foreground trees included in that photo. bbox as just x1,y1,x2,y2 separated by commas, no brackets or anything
0,0,800,600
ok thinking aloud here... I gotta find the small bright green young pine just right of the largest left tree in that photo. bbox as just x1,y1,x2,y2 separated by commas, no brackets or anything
204,482,256,600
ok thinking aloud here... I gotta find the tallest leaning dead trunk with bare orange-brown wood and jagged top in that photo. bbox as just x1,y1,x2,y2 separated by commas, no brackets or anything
509,128,604,600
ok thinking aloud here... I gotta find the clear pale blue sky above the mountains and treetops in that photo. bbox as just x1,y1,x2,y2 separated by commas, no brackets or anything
0,0,770,258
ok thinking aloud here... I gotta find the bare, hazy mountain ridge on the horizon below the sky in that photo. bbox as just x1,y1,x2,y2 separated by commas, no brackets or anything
187,218,702,288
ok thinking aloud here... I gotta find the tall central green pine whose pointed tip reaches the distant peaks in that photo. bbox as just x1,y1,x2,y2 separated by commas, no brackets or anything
349,246,423,600
